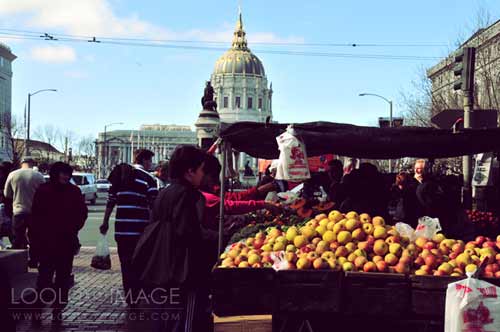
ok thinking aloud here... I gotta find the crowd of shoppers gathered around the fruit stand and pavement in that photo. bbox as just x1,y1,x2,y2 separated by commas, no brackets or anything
0,146,474,331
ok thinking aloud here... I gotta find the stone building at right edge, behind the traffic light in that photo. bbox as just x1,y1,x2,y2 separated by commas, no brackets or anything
427,20,500,123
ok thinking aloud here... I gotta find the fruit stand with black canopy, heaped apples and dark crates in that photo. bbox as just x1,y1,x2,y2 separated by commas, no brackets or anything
213,122,500,332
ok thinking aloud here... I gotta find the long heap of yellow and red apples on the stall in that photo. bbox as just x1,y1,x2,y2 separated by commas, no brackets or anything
219,210,500,277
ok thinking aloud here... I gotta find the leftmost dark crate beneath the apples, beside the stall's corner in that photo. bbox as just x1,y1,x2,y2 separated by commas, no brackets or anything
212,268,276,317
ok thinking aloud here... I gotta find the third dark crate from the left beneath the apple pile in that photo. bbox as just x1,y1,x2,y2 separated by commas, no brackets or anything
342,272,410,316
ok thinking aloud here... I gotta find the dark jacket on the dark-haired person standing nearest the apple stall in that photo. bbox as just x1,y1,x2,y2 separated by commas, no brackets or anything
133,180,206,285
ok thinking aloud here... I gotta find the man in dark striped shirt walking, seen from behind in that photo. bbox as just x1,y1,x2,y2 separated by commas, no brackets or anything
100,149,158,307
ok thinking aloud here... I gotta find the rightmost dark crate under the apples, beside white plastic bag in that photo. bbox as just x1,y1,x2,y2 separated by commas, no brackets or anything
410,275,464,318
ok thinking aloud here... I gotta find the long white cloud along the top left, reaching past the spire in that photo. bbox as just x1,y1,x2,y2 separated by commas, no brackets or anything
0,0,303,44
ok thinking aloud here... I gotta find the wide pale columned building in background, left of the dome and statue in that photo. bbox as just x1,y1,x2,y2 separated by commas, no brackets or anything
96,124,197,178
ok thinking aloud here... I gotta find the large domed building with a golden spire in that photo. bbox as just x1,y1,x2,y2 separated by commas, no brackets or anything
211,12,273,123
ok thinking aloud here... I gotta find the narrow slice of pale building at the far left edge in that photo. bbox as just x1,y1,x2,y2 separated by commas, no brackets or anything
0,43,17,160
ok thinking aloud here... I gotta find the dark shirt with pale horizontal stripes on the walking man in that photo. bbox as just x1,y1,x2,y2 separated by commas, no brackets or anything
108,165,158,239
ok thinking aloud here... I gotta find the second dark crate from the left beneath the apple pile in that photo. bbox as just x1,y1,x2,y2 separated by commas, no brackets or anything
275,270,344,313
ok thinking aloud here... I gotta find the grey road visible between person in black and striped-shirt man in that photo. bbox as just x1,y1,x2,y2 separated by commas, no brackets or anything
78,194,116,247
